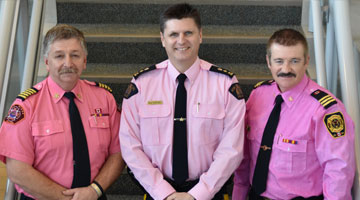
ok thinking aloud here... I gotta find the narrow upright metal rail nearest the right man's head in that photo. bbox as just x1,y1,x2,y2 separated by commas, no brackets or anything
311,0,327,88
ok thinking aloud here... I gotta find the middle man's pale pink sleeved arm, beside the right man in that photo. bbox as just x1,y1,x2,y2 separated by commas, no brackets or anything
189,77,245,199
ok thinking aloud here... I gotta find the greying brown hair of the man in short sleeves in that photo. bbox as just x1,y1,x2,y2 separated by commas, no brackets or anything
43,24,87,57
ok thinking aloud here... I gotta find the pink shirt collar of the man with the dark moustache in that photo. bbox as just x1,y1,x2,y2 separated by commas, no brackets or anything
275,75,309,107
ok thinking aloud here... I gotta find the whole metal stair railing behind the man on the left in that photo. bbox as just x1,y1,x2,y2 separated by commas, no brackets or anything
0,0,44,200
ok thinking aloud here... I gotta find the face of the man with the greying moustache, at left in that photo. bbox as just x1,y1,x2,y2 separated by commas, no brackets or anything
45,38,86,91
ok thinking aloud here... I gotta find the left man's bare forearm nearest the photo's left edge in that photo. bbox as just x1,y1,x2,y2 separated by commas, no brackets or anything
6,158,71,200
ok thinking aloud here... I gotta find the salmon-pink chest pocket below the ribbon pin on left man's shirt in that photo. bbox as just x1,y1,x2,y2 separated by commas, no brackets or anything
88,116,111,151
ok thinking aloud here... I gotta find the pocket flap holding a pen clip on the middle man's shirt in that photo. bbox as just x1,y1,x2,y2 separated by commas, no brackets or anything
192,104,225,119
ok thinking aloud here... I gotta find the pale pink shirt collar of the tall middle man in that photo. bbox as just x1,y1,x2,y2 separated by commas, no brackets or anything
168,57,200,84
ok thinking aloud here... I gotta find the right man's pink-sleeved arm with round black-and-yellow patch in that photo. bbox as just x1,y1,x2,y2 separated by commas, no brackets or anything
315,105,355,200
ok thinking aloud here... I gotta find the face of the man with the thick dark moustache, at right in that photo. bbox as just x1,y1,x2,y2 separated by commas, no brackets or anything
266,43,309,92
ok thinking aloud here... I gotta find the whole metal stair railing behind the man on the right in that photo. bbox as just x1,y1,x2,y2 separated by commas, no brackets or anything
311,0,360,199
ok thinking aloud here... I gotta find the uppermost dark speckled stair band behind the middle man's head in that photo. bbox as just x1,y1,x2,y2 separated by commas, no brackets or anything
57,1,301,26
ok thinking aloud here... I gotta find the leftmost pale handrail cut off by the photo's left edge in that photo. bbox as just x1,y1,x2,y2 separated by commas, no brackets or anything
0,1,16,97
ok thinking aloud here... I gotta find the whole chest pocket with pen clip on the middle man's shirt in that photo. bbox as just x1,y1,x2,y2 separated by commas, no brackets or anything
188,104,225,144
